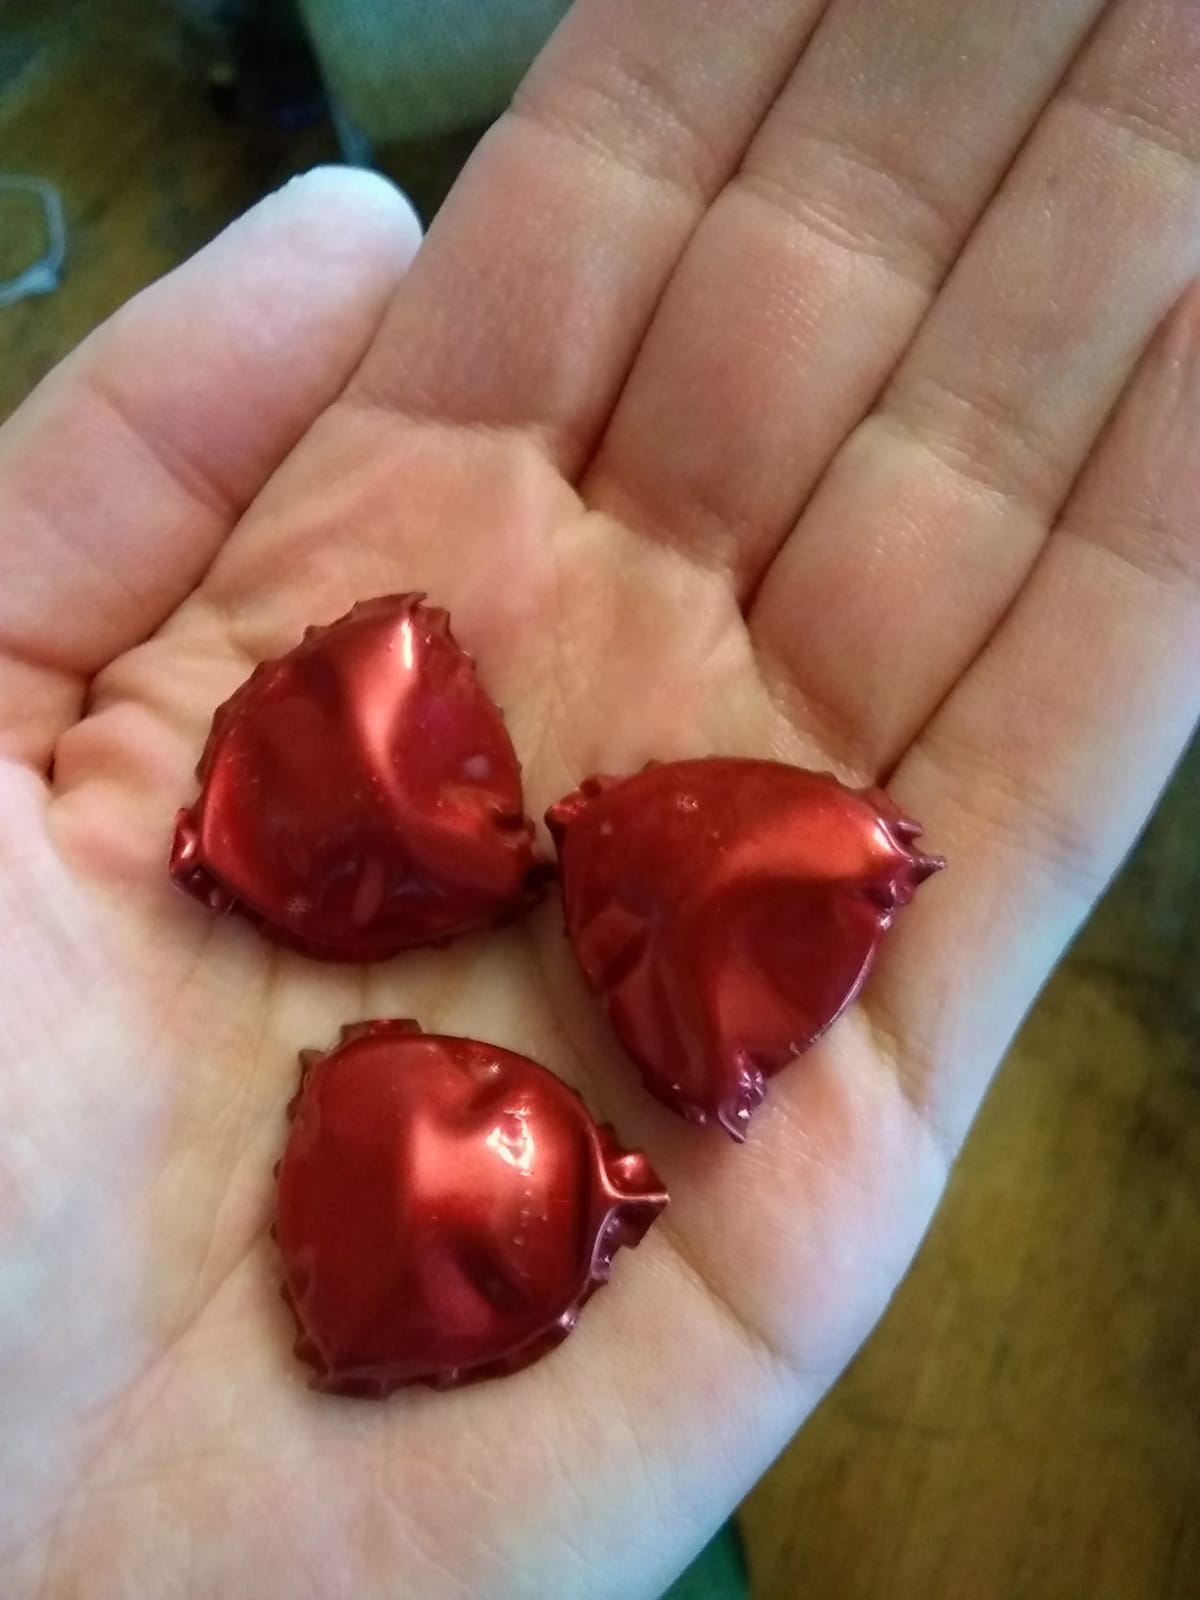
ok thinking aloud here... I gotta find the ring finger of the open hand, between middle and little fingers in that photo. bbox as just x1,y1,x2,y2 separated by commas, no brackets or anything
752,0,1200,773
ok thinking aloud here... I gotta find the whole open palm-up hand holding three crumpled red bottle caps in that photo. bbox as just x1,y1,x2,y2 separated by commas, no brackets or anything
0,0,1200,1600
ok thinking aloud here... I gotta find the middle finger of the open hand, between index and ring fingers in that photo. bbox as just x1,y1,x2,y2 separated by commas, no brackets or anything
586,0,1099,595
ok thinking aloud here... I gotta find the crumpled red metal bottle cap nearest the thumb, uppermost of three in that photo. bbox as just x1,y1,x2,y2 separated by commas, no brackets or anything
170,595,544,960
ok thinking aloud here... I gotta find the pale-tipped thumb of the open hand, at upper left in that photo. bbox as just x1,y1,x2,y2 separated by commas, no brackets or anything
0,171,419,765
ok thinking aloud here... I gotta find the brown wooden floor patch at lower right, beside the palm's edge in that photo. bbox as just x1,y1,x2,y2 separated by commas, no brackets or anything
742,750,1200,1600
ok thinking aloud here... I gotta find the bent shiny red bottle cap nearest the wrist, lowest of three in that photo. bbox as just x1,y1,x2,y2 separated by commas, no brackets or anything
275,1021,667,1397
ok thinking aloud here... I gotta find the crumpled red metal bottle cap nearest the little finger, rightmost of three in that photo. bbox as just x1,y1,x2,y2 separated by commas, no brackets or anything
546,757,942,1139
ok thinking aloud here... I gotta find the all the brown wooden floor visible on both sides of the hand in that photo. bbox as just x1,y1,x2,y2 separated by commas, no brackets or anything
0,0,1200,1600
